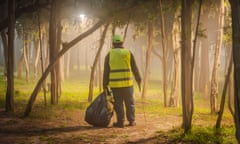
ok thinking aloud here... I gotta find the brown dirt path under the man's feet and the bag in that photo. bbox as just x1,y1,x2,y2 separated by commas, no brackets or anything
0,110,181,144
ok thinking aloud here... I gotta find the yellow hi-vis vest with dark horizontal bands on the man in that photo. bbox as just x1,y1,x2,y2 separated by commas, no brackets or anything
109,48,133,88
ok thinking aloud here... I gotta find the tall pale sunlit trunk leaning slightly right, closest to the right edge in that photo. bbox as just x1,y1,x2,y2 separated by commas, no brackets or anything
210,0,224,113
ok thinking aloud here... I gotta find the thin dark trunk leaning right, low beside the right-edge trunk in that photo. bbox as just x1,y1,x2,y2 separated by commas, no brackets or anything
216,52,232,129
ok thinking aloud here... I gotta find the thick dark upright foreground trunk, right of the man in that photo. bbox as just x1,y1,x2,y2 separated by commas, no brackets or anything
181,0,193,133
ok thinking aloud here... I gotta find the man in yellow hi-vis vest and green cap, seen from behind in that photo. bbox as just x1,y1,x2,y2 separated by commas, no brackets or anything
103,35,141,128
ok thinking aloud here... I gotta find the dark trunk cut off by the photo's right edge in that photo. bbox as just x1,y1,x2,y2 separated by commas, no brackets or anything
229,0,240,143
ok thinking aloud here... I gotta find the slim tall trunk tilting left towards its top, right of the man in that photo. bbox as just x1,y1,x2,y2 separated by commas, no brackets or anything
159,0,168,107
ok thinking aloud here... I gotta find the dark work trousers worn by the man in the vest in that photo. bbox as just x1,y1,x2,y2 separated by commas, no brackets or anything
111,86,135,123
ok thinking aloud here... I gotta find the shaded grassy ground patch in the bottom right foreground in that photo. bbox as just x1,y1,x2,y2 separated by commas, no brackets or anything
128,127,233,144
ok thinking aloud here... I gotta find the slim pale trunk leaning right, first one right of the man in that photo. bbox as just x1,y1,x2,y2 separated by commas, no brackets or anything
142,22,153,98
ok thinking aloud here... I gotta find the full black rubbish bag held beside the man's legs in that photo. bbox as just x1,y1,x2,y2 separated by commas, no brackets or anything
85,92,113,127
